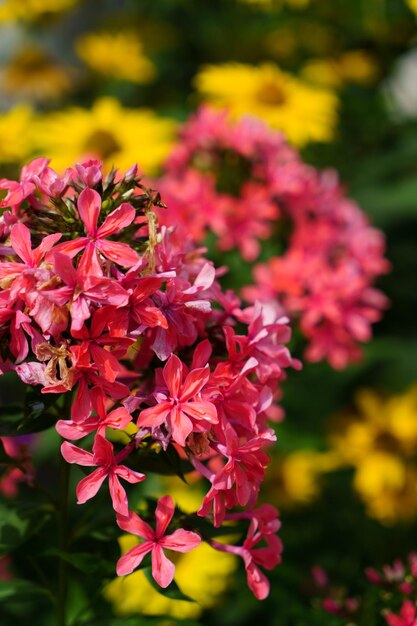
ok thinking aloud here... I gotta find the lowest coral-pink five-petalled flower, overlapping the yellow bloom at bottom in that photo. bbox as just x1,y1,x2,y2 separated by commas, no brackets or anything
117,496,201,588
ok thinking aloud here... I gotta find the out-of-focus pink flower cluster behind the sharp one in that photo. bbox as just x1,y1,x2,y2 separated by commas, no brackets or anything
158,107,389,369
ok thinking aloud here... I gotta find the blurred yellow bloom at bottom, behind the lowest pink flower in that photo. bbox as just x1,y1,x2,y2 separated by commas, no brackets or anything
104,536,237,619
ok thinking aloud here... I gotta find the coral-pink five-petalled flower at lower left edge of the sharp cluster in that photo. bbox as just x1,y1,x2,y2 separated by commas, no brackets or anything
61,435,146,515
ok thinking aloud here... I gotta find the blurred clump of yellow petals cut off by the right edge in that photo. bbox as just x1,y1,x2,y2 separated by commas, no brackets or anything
330,385,417,523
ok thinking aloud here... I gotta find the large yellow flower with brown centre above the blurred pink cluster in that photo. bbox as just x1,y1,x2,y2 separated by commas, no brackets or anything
195,63,338,146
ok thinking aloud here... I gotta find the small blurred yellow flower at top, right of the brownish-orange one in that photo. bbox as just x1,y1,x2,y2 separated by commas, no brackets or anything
75,32,156,83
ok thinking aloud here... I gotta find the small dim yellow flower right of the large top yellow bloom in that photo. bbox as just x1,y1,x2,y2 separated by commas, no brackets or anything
303,50,378,88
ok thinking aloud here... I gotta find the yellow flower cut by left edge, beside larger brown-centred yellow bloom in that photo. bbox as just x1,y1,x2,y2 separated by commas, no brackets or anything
0,105,33,164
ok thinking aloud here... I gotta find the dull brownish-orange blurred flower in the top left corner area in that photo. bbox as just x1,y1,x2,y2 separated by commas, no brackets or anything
2,46,72,101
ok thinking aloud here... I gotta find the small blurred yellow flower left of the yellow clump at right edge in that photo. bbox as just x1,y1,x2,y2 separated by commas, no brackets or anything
269,450,339,507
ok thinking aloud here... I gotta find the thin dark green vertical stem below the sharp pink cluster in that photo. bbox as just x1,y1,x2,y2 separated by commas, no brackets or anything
56,393,72,626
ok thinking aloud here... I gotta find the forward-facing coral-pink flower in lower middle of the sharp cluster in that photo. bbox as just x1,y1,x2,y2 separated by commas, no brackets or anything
137,354,218,446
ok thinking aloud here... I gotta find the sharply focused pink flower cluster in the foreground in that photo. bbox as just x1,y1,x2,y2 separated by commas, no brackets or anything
0,158,299,598
